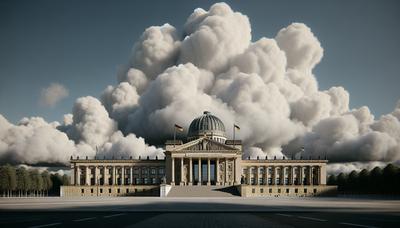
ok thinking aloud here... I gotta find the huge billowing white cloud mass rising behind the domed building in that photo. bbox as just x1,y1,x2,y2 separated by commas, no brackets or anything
0,3,400,167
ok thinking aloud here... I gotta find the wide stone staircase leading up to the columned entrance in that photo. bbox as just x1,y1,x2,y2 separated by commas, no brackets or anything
167,185,239,197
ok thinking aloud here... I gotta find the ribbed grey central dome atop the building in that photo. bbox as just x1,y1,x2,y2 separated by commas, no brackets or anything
188,111,226,143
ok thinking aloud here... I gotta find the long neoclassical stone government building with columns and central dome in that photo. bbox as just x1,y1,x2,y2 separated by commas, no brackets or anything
60,112,336,197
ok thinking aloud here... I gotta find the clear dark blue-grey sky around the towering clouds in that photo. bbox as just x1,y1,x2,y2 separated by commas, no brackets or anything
0,0,400,123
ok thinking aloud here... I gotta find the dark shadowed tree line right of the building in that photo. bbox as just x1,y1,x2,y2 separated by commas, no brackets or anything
328,164,400,194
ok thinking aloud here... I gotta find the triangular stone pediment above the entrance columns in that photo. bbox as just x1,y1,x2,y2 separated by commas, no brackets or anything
174,137,238,151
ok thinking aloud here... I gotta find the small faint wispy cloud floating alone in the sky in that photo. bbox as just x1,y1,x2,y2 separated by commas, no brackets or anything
39,83,69,107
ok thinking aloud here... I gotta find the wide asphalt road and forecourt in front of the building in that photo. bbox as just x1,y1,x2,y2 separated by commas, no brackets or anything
0,197,400,228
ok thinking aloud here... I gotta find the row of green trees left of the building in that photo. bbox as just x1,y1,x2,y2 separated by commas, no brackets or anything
0,164,69,197
